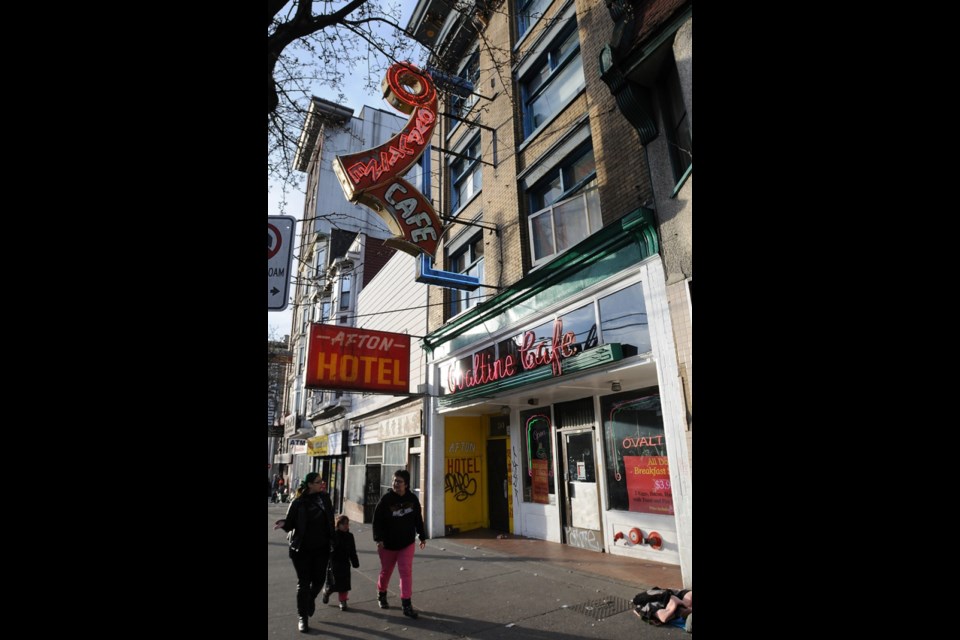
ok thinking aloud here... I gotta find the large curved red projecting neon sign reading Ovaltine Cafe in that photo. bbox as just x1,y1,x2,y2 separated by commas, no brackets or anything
333,62,443,258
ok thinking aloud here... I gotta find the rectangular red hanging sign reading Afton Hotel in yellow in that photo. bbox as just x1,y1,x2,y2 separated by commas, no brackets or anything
304,323,410,393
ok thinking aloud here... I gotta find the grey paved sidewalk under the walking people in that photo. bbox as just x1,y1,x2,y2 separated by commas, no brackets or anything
267,504,692,640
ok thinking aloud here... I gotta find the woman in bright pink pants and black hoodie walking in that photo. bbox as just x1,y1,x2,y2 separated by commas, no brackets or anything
373,469,427,618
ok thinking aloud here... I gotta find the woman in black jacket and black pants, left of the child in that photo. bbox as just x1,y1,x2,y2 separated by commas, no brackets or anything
273,472,333,633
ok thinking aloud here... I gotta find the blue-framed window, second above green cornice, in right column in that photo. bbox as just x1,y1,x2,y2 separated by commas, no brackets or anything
520,21,585,138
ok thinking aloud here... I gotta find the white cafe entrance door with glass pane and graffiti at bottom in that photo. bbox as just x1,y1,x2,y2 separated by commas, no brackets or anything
557,427,603,551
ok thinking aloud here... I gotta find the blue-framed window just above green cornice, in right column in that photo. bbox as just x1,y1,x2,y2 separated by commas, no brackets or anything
527,140,603,266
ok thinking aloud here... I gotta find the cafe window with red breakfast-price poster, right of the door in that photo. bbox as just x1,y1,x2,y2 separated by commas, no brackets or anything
600,387,673,515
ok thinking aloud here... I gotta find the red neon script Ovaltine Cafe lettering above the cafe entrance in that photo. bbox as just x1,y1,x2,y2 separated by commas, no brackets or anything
447,318,578,393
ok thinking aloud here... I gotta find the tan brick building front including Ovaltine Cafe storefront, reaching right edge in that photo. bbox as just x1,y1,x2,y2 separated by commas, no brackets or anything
408,0,693,588
